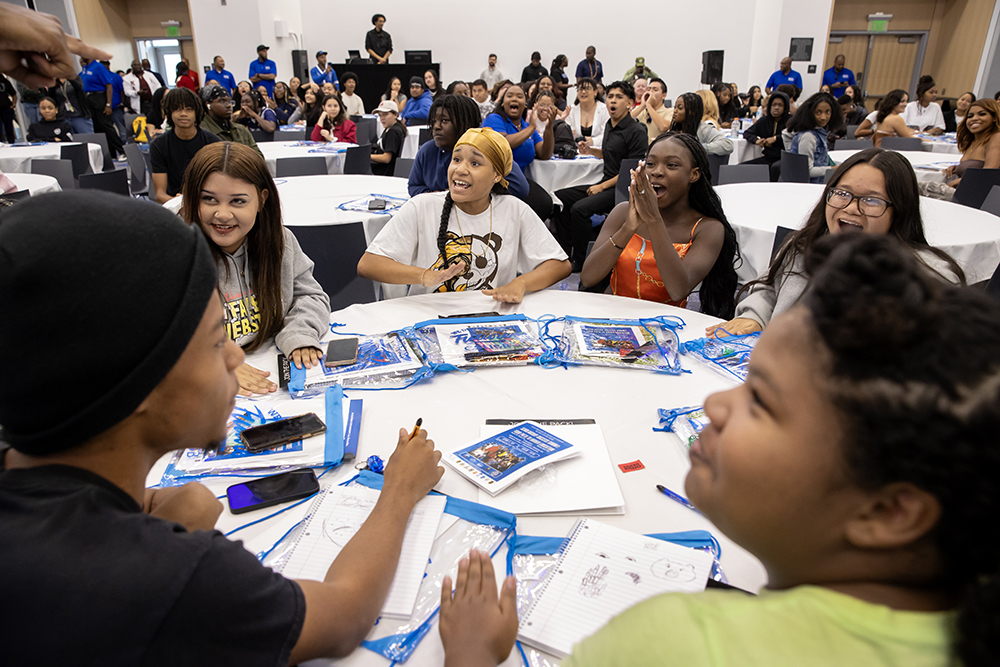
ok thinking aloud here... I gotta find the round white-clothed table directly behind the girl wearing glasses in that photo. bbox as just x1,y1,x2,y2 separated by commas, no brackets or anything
715,183,1000,284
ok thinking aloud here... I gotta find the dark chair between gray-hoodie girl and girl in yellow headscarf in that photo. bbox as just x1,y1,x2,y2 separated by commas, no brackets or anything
288,222,377,310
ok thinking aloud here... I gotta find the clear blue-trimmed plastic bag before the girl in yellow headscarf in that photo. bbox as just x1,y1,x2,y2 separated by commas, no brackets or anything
408,315,545,370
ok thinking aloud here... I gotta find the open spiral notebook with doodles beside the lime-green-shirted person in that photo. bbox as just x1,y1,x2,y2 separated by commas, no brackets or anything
518,518,712,657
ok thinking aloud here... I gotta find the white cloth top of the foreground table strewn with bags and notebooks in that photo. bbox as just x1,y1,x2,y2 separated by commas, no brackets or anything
150,290,766,667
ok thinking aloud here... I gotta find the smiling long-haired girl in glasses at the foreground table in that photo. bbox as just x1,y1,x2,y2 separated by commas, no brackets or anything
706,148,965,335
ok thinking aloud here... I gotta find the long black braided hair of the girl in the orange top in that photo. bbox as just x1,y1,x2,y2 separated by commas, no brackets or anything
646,132,743,319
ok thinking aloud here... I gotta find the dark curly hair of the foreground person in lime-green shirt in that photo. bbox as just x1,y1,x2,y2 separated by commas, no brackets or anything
801,234,1000,667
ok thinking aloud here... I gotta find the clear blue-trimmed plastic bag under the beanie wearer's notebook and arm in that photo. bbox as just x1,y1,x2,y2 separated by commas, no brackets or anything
262,471,516,662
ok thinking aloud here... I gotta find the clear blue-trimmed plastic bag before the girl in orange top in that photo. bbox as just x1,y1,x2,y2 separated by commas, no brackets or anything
546,316,684,375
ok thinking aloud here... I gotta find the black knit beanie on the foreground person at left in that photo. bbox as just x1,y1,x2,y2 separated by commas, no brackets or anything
0,190,216,456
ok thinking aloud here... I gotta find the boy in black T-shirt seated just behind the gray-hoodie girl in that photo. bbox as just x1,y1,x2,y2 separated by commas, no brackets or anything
149,86,222,204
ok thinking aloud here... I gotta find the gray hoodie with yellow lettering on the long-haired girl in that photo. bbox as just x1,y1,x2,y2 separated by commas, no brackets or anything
219,228,330,355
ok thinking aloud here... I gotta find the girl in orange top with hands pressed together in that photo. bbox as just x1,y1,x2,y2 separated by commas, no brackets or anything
580,132,739,318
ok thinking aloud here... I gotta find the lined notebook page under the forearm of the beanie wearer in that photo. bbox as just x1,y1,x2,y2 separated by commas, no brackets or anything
279,486,447,618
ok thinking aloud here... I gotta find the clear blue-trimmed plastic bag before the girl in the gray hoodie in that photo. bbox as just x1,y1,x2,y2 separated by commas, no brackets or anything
288,331,431,398
